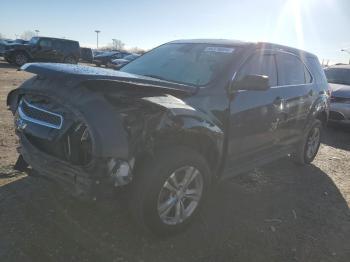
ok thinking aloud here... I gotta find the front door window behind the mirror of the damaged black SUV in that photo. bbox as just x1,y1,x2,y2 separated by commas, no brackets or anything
237,53,277,86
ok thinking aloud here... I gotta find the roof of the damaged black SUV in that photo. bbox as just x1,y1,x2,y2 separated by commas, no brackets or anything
170,39,316,57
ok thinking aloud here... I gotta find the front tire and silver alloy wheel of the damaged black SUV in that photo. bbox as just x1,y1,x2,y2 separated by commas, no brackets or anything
129,147,211,236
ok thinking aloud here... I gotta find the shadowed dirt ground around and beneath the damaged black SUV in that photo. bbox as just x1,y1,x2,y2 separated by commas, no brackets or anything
0,60,350,262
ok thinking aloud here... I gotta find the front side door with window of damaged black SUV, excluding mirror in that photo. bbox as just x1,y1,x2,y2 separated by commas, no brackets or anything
227,51,283,168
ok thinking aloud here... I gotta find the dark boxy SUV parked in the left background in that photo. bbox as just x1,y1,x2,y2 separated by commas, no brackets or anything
4,37,80,66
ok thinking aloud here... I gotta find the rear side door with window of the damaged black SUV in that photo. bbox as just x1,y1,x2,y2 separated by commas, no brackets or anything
276,52,316,145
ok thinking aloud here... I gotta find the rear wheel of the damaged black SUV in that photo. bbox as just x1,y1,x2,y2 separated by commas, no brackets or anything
292,119,322,165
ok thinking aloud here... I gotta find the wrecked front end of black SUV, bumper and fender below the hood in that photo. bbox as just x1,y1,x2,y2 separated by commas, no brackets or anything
7,63,223,197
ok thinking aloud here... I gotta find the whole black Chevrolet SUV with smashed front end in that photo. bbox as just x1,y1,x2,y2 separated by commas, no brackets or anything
7,40,329,234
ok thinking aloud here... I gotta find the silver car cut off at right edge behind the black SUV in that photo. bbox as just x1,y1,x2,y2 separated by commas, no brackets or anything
325,65,350,124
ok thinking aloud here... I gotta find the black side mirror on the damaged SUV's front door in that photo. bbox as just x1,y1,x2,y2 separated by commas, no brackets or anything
231,75,270,91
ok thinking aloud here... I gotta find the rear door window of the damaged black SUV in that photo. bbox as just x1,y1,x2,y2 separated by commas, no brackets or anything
276,53,312,86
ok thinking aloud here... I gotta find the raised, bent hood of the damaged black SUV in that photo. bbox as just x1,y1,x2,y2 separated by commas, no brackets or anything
21,63,197,94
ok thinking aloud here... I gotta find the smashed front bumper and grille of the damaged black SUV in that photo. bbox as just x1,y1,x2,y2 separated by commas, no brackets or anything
9,84,134,199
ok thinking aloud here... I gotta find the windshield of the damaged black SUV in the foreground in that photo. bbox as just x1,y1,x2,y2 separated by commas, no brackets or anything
120,43,235,86
